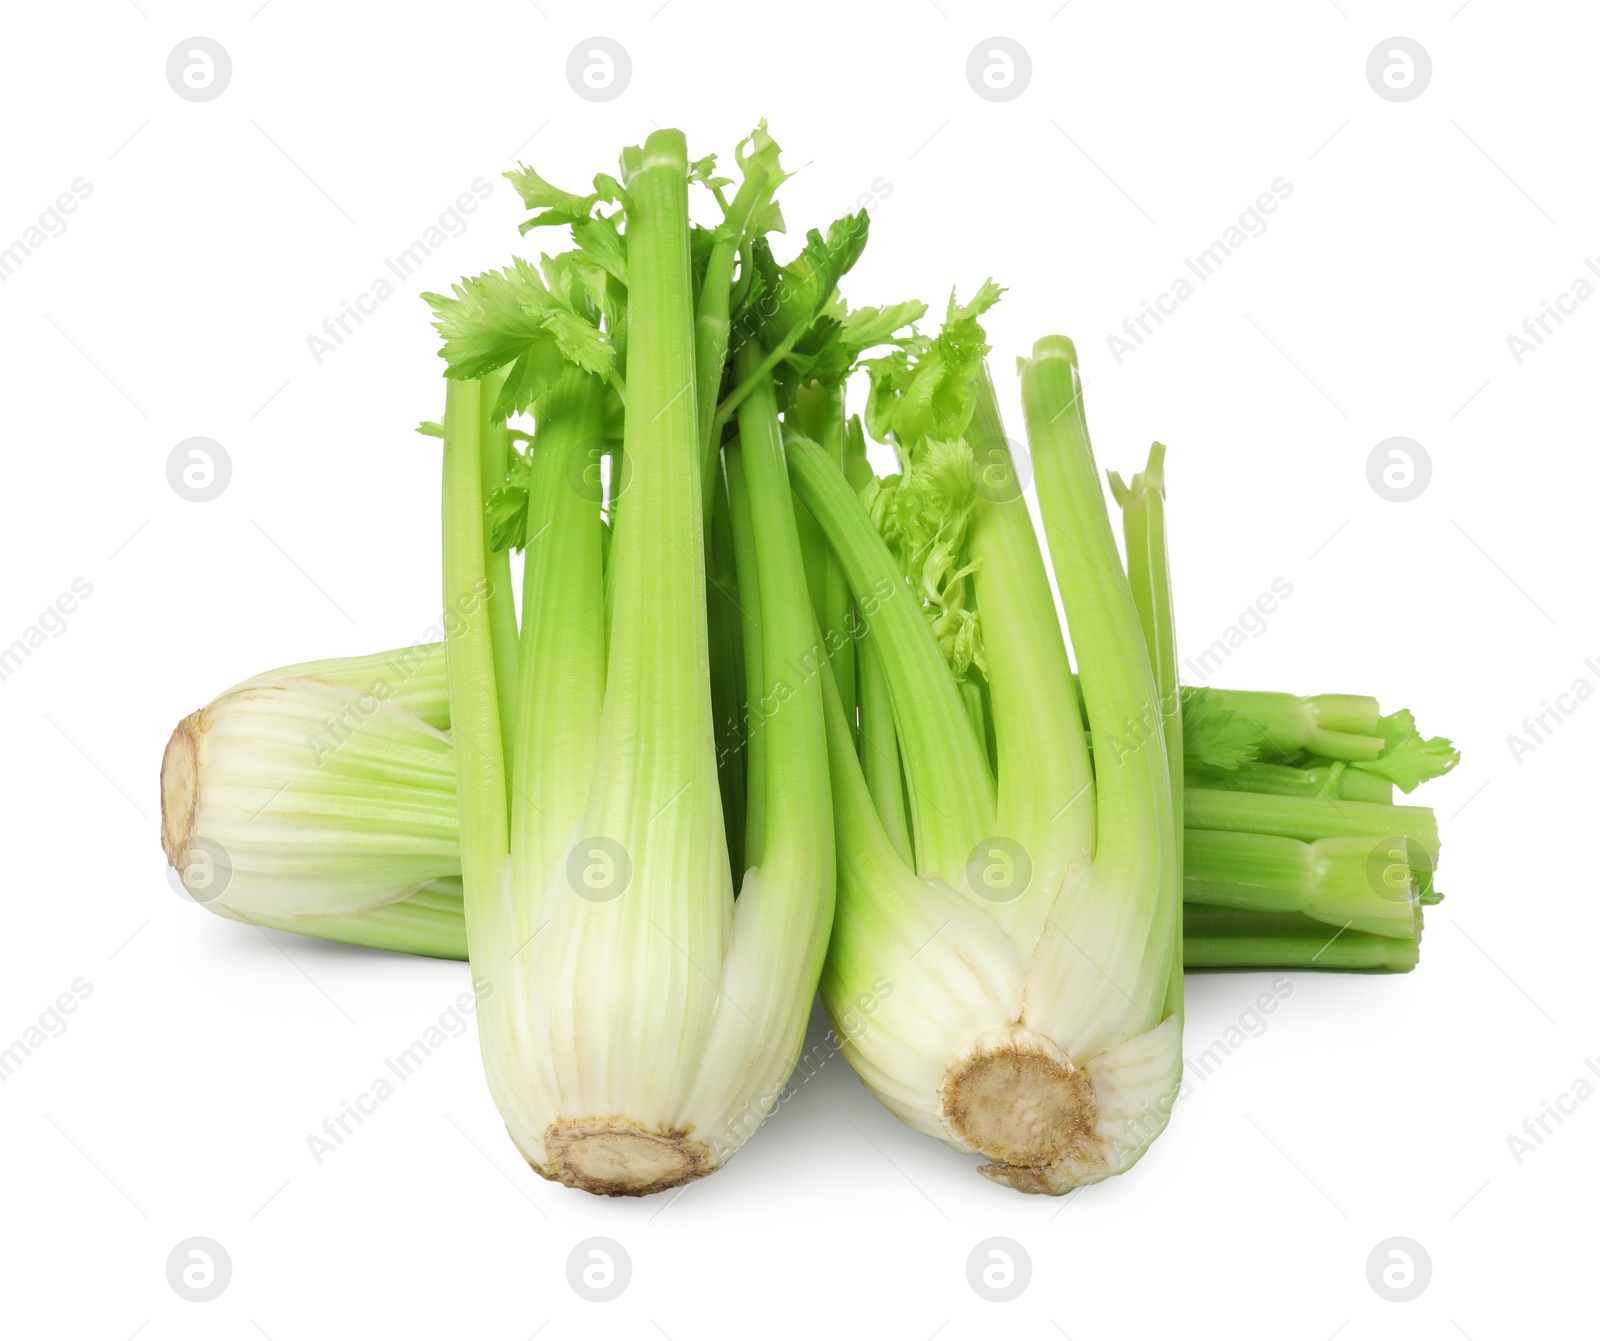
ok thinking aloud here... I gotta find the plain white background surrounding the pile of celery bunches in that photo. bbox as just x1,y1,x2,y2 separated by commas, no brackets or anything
0,0,1600,1341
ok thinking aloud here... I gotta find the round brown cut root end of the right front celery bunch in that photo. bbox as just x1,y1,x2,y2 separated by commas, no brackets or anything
939,1037,1098,1186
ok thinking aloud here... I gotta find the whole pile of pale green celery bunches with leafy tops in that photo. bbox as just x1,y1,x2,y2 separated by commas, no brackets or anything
162,123,1458,1195
